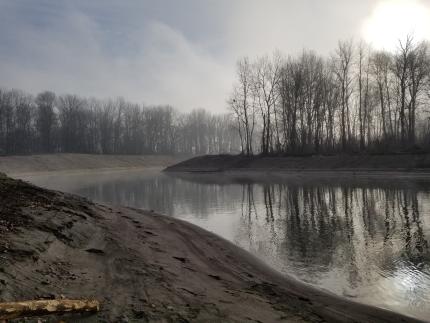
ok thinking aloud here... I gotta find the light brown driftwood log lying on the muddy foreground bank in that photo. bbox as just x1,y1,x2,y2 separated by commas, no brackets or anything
0,299,100,320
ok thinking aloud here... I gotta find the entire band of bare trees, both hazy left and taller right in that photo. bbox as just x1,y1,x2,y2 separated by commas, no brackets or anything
0,37,430,155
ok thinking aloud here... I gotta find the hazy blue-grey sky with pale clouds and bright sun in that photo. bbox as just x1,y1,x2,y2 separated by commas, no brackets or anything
0,0,430,111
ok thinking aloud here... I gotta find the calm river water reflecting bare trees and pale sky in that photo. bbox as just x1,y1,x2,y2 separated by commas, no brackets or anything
19,171,430,320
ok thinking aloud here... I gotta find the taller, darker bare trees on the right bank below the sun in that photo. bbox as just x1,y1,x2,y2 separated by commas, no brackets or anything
229,37,430,155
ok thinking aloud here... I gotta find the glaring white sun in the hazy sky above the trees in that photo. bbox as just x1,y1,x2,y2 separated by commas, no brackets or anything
362,0,430,51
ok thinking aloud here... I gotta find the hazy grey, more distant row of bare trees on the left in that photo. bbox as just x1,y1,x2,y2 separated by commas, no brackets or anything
0,89,240,155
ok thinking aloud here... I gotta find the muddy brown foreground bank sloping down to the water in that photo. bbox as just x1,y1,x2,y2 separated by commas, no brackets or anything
0,176,424,322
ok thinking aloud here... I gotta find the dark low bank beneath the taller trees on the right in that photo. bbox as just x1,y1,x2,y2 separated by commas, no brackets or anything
166,154,430,172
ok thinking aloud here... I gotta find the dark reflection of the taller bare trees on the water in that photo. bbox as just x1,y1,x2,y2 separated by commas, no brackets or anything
235,183,430,313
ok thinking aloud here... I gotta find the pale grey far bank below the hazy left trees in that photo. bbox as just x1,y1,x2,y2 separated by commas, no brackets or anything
0,154,184,174
